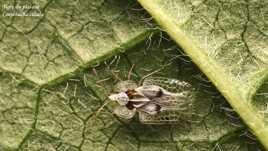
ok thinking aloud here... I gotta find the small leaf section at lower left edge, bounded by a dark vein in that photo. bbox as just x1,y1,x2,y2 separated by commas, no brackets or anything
0,71,38,150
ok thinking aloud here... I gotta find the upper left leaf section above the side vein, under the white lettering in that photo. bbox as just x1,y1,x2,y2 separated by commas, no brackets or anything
0,0,149,85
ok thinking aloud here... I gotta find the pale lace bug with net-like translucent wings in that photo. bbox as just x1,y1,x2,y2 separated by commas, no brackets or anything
109,77,195,124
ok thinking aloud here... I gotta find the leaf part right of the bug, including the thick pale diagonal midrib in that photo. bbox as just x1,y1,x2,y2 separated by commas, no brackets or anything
138,0,268,149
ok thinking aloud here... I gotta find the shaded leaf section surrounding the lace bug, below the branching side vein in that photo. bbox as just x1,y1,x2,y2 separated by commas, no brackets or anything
0,36,260,151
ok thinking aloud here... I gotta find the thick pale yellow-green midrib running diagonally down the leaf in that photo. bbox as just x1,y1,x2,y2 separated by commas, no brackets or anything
138,0,268,149
